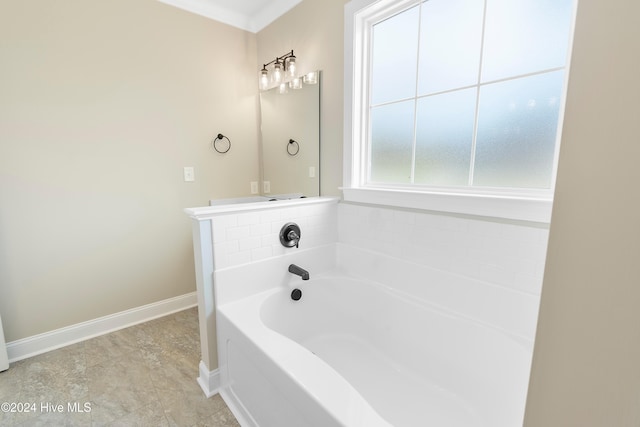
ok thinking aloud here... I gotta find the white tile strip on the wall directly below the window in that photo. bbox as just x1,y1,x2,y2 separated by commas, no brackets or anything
338,203,549,297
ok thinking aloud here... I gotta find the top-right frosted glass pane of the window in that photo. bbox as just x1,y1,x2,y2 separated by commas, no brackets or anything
482,0,573,82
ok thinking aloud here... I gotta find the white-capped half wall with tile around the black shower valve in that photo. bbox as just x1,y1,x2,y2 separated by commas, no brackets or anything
185,197,338,396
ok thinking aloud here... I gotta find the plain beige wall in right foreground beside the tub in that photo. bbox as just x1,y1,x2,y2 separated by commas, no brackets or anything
525,0,640,427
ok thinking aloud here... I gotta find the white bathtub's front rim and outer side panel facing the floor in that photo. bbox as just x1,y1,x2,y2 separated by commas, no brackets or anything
217,272,390,427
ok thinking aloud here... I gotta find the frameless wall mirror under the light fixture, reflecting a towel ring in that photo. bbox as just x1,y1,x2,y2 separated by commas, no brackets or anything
260,71,321,199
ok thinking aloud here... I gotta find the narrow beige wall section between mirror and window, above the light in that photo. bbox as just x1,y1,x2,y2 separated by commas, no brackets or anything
256,0,348,196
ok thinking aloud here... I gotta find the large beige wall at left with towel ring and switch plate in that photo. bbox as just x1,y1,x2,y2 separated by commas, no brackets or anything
0,0,258,341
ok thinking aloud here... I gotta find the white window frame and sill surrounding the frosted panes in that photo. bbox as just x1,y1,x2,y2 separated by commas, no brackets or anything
341,0,577,223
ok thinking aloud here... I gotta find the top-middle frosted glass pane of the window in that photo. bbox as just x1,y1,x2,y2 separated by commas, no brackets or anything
418,0,484,95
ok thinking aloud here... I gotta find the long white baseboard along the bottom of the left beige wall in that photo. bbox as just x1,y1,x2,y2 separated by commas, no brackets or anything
7,292,198,362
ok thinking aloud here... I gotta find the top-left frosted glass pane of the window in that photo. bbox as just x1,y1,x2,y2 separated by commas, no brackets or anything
371,6,420,105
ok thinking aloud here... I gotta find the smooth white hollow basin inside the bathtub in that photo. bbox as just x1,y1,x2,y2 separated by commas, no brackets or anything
260,274,530,426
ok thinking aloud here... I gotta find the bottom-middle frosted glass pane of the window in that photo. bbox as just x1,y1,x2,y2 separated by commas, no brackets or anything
415,88,476,186
